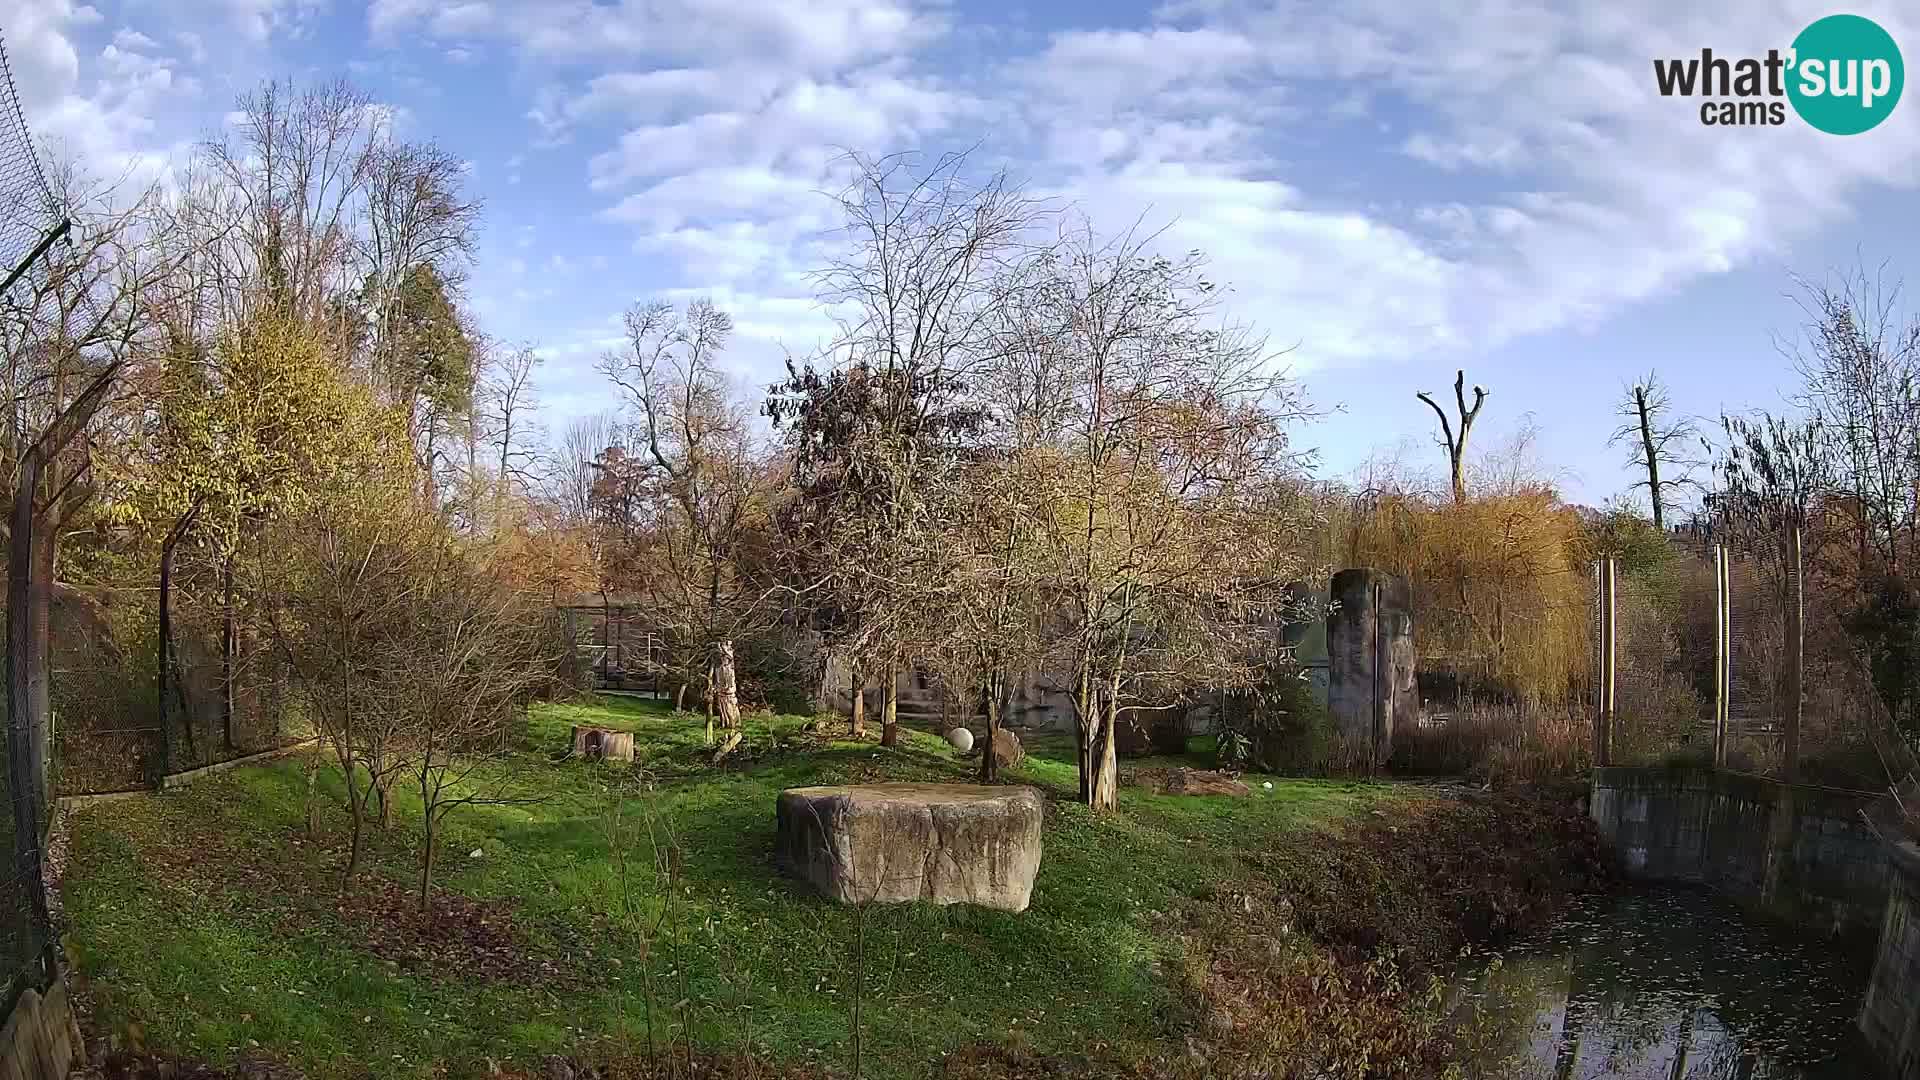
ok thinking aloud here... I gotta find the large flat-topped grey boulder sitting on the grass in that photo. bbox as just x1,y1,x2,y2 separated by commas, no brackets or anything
776,784,1044,911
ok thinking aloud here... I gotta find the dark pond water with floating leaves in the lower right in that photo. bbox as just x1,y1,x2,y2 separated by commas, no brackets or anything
1459,890,1880,1080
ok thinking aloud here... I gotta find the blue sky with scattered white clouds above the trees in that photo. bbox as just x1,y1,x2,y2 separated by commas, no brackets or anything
0,0,1920,502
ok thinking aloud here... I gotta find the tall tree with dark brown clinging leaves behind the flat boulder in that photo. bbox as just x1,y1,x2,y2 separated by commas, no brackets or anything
766,154,1048,746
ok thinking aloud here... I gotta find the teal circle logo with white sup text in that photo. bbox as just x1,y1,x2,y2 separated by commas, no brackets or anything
1788,15,1907,135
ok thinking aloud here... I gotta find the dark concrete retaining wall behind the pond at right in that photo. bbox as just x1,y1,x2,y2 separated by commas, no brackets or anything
1590,767,1889,940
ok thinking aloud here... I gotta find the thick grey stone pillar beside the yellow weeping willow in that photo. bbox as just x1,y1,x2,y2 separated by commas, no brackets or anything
1327,569,1421,765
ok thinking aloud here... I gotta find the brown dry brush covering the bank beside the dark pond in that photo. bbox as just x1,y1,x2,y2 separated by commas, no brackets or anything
1156,790,1607,1080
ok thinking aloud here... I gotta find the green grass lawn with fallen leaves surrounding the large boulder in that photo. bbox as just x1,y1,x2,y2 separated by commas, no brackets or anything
63,698,1388,1078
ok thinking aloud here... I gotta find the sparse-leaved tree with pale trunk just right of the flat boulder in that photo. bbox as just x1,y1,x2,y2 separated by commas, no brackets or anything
1021,227,1306,807
